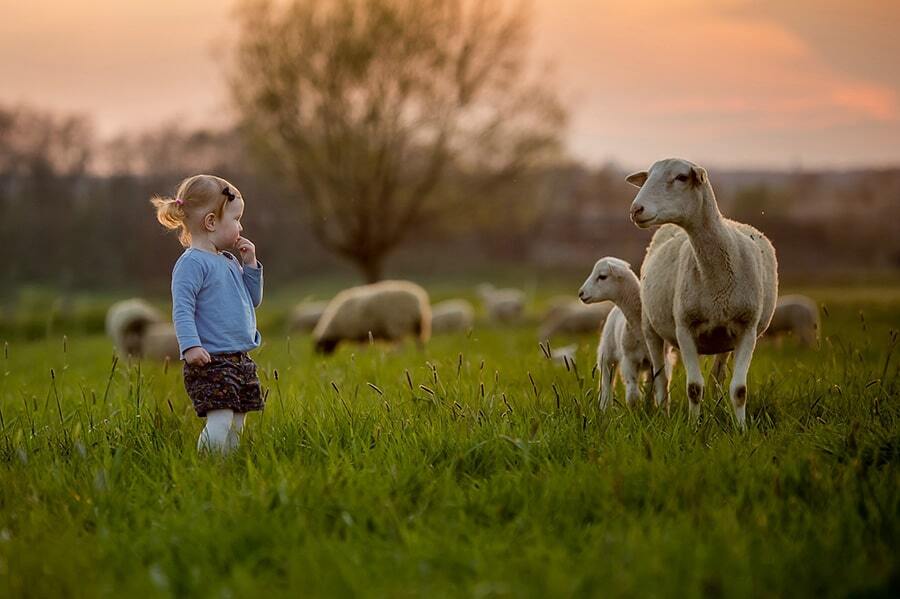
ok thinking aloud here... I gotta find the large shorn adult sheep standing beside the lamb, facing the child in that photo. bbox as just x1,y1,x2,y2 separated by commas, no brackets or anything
626,159,778,428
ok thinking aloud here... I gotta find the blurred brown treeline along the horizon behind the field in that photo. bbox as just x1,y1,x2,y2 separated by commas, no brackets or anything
0,107,900,293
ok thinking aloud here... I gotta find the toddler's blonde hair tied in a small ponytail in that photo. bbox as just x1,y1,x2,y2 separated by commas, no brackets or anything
150,175,243,247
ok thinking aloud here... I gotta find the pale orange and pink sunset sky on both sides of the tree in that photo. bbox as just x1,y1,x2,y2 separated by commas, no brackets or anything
0,0,900,168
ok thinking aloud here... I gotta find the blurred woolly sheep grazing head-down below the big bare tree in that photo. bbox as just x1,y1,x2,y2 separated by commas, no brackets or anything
313,281,431,354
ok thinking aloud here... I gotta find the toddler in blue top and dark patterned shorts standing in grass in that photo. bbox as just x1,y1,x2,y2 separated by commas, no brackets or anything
151,175,264,453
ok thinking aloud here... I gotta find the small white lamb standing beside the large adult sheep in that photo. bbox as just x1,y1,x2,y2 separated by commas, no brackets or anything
578,257,651,410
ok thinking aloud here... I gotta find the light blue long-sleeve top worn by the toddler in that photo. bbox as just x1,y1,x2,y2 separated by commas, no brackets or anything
172,248,263,358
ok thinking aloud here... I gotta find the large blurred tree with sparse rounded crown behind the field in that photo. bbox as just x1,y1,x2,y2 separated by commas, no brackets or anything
231,0,565,281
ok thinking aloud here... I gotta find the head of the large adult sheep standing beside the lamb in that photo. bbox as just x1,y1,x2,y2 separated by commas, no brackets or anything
625,158,715,229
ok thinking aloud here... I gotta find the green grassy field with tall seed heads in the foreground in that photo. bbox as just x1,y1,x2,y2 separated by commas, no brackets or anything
0,287,900,597
